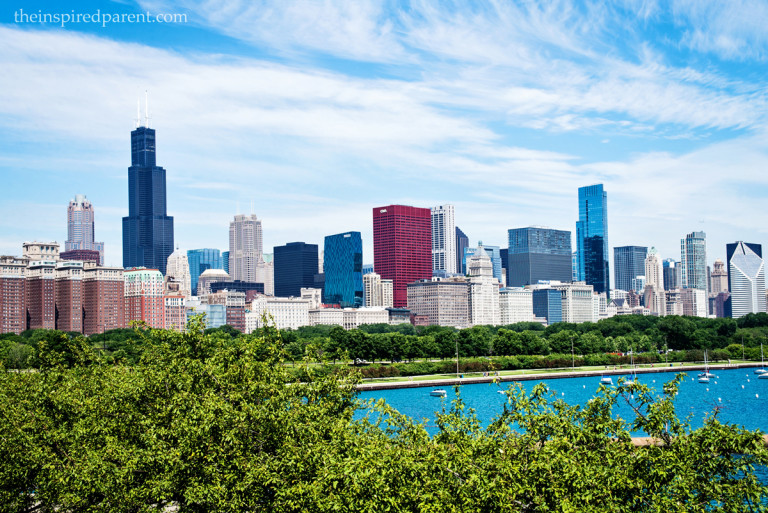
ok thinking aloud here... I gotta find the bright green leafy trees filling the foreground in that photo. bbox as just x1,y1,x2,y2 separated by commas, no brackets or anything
0,321,768,512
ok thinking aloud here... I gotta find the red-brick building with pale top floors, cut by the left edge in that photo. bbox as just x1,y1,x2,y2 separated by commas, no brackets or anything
0,256,27,335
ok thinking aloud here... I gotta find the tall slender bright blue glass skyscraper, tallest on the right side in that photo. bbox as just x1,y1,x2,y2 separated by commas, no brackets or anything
576,184,611,299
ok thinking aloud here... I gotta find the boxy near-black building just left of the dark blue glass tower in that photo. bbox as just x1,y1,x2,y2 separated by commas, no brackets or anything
273,242,318,297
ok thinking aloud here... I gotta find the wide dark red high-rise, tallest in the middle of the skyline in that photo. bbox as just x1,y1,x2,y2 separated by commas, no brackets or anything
373,205,432,308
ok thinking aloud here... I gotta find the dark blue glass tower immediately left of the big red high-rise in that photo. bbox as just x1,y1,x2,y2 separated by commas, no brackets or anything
323,232,363,308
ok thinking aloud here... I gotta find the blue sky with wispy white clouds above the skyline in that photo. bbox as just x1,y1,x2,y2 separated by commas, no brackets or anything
0,0,768,274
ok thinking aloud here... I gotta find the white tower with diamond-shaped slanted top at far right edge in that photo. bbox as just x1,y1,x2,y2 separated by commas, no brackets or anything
725,241,765,319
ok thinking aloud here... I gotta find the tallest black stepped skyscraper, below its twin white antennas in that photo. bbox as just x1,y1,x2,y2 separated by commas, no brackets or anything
123,119,173,274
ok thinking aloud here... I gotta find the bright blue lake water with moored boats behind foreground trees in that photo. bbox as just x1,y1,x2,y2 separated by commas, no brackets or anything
358,369,768,436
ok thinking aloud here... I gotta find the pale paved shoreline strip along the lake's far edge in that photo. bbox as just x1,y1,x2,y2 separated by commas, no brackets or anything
356,362,762,392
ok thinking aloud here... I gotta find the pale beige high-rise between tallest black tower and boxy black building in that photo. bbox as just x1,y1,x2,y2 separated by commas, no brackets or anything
229,214,264,282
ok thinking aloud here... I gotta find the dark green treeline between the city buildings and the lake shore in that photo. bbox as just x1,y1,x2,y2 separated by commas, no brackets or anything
0,313,768,370
